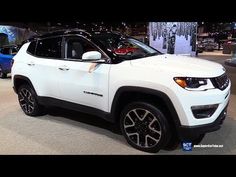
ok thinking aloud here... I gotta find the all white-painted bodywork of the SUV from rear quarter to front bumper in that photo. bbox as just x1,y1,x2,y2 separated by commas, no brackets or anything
12,44,230,126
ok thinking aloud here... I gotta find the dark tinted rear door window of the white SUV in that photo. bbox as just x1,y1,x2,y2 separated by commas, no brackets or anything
36,37,62,58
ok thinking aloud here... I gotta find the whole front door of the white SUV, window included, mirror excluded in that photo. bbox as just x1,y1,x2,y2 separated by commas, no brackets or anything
58,36,110,111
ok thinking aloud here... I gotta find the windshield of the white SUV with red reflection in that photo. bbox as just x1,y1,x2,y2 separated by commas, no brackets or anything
95,34,161,60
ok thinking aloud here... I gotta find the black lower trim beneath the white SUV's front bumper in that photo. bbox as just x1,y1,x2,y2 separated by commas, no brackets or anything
178,104,228,141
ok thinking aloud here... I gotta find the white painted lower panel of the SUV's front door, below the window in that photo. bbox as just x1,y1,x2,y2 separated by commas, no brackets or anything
57,61,110,111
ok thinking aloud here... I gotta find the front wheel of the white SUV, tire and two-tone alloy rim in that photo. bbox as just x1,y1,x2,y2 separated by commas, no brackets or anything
120,102,170,153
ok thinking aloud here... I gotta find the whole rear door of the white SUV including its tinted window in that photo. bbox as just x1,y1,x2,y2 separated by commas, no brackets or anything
25,37,62,98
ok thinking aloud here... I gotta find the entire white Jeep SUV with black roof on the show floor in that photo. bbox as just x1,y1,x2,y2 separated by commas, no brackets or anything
12,30,231,152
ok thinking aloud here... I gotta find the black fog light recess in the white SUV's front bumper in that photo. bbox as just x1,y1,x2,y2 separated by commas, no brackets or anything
191,104,218,119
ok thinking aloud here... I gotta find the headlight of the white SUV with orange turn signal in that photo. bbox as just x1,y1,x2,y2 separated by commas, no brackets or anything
174,77,214,90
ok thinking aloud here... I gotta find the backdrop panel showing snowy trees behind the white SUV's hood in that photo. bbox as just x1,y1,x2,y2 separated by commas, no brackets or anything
149,22,197,55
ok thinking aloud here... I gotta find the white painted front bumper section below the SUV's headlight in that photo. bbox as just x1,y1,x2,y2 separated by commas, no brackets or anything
171,79,231,127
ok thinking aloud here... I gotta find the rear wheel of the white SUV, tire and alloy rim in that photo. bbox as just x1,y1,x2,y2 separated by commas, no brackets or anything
17,85,44,116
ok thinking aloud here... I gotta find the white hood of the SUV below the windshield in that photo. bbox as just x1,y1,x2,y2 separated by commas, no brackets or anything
131,54,225,77
